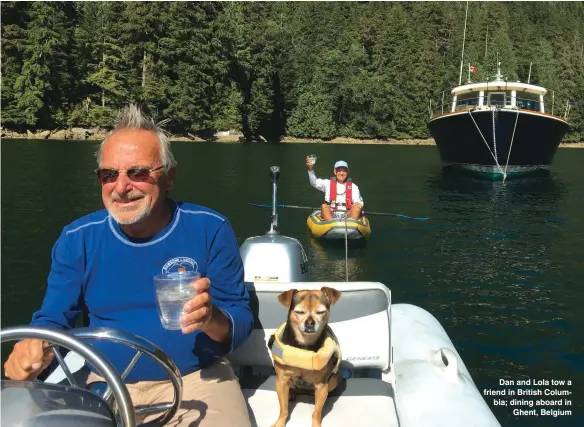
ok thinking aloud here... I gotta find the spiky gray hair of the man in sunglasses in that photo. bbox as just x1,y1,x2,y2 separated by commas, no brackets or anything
95,104,177,172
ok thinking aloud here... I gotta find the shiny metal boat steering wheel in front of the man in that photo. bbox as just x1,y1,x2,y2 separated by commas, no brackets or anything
0,326,183,427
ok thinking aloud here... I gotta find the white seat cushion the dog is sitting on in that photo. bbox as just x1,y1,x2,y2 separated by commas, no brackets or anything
240,376,399,427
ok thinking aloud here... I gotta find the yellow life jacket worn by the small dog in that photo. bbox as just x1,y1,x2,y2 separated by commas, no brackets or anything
270,322,342,373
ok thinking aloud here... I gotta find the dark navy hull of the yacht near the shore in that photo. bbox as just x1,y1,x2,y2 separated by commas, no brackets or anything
428,109,569,179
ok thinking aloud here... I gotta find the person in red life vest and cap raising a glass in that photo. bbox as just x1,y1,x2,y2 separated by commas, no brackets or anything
306,157,364,221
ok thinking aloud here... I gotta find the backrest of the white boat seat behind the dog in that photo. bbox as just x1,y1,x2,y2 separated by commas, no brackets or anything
229,282,391,373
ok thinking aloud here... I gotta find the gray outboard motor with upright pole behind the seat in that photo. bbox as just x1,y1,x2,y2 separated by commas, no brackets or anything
239,166,308,282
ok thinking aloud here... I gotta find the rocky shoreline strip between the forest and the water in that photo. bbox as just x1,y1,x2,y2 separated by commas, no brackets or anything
1,128,584,148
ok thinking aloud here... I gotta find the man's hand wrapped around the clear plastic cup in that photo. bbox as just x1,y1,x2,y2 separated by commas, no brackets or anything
180,277,230,343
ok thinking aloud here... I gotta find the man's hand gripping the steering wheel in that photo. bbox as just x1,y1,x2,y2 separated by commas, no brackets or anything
4,339,55,381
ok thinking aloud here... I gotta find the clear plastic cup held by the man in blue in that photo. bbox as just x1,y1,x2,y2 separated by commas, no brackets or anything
154,271,201,331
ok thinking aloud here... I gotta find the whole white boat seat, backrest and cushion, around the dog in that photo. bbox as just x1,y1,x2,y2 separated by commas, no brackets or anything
229,282,399,427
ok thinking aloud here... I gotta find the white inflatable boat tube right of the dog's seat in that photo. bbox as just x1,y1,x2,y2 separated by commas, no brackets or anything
391,304,500,427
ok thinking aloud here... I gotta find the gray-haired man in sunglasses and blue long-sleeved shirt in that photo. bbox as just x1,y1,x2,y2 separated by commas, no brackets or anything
5,106,253,427
